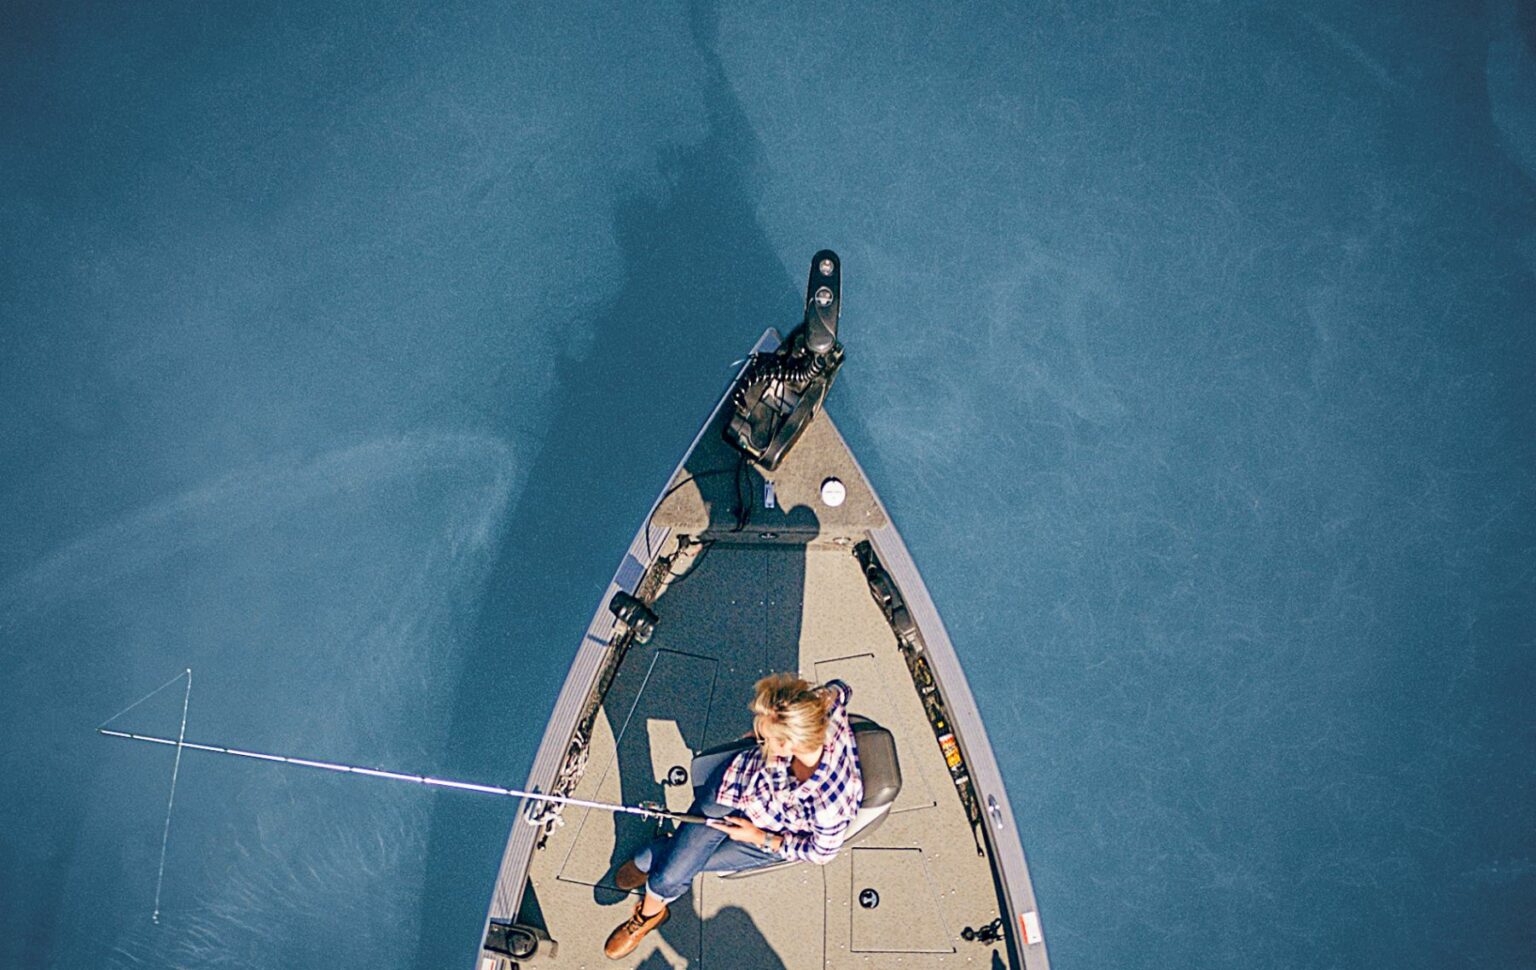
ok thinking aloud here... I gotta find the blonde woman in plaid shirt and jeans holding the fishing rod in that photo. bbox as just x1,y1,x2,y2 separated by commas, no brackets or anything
604,674,863,959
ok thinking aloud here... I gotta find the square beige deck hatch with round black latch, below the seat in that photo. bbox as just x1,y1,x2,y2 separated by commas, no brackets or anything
848,846,954,953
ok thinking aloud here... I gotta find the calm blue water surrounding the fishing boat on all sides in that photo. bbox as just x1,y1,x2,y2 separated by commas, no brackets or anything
0,0,1536,968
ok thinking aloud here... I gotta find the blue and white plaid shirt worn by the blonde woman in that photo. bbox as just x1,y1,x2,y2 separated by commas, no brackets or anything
714,680,863,866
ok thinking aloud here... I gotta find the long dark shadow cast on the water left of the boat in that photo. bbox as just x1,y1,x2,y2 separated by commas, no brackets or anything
413,3,796,965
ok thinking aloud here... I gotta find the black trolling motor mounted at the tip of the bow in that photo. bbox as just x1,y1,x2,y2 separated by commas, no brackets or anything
723,249,843,471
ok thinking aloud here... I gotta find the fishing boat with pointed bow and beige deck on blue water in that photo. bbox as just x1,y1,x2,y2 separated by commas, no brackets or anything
478,250,1049,970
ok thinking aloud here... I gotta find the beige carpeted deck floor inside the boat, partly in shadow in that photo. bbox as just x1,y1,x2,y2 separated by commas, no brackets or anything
522,414,1008,970
